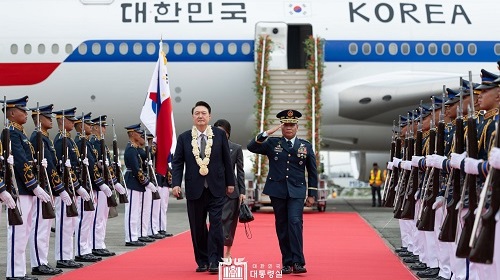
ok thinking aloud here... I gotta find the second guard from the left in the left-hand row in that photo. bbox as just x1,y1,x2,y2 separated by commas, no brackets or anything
30,104,66,275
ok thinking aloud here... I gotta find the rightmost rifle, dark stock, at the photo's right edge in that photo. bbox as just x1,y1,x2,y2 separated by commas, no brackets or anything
469,106,500,264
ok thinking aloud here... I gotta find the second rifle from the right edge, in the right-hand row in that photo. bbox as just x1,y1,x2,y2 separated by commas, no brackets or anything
456,71,478,258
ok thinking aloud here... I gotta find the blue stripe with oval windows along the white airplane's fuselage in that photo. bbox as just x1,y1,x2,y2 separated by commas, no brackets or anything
65,40,500,62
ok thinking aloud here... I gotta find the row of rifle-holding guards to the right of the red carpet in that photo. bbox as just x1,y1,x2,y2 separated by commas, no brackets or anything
383,61,500,279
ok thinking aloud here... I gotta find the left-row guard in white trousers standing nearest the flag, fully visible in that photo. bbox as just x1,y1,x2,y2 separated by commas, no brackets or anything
124,124,157,246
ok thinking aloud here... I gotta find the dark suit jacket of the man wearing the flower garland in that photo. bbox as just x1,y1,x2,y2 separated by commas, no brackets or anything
172,126,235,200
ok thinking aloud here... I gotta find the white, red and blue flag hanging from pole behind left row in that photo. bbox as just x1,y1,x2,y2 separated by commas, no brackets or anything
140,41,177,176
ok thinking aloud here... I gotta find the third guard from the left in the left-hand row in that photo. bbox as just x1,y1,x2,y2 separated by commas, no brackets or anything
53,107,90,268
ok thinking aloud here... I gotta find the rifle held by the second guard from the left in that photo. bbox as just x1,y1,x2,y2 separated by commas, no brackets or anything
36,102,56,219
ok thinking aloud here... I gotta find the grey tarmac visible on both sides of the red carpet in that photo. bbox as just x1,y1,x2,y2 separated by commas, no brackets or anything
0,197,408,279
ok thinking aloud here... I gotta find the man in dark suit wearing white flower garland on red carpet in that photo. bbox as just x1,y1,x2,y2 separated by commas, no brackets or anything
172,101,235,273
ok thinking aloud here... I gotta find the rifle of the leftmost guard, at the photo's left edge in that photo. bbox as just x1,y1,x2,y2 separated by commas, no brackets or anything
2,96,23,226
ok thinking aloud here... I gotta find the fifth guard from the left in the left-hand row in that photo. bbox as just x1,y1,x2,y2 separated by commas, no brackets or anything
90,115,126,257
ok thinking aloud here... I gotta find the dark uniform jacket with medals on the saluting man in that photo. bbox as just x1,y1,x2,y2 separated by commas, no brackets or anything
247,133,318,199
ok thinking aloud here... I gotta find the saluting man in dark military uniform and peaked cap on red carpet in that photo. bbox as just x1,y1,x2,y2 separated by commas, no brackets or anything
247,110,318,274
